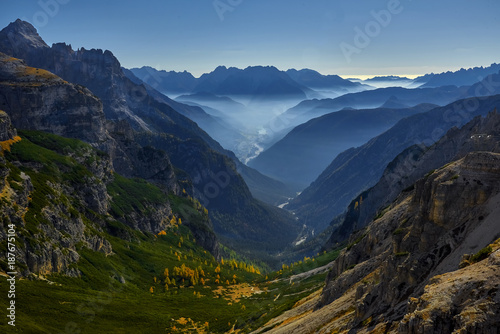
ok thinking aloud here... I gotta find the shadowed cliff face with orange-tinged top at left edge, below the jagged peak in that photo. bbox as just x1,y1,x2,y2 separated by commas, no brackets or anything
0,53,109,145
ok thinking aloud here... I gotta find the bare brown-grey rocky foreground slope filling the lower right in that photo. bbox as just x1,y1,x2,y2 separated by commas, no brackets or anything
256,152,500,333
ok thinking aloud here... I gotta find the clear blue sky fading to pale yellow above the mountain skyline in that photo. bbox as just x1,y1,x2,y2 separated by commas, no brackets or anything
0,0,500,78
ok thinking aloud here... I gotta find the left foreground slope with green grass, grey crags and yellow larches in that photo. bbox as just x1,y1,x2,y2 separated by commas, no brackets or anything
0,115,292,333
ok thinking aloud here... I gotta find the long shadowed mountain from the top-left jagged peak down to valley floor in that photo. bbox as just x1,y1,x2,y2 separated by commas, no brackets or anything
0,20,300,256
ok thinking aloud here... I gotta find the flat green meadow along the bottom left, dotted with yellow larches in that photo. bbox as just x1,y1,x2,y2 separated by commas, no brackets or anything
0,234,340,333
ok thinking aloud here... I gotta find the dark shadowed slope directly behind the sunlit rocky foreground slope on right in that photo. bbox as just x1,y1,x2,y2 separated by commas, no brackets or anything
330,110,500,245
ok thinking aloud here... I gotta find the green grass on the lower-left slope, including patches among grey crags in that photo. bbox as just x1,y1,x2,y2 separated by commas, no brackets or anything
0,132,336,333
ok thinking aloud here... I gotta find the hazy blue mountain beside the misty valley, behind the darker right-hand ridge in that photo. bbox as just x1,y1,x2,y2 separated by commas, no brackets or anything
248,105,433,190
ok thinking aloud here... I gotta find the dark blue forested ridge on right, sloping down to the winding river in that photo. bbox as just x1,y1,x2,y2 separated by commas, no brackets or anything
287,91,500,234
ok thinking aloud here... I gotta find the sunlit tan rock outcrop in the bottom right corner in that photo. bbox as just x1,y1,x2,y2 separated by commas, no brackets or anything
397,240,500,334
